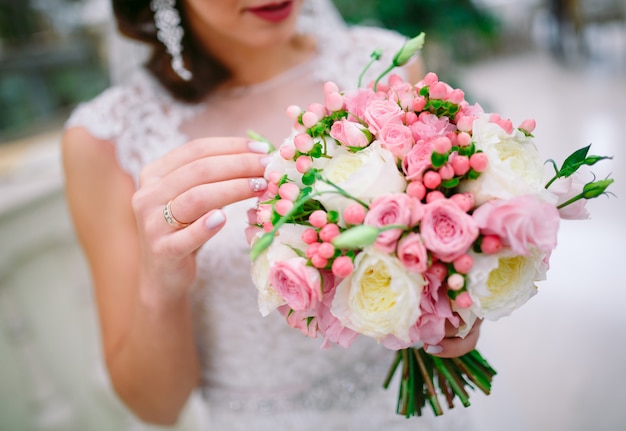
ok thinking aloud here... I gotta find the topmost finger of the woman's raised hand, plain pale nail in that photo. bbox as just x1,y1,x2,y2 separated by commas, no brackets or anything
139,137,269,185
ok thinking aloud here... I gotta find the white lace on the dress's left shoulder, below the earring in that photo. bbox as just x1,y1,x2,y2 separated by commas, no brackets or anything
66,70,203,181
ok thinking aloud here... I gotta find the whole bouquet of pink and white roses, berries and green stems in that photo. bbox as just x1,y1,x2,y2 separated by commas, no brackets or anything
251,34,613,417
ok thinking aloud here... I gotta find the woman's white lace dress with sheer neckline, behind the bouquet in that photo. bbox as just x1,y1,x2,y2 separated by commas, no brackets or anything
67,24,472,431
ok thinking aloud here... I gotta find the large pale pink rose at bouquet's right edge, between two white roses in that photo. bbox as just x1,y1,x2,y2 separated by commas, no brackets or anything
473,195,560,255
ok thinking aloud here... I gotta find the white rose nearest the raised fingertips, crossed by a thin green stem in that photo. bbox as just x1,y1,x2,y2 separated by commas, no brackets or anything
313,141,406,223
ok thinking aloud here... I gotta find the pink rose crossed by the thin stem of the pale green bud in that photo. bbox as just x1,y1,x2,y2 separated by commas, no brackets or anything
364,193,413,253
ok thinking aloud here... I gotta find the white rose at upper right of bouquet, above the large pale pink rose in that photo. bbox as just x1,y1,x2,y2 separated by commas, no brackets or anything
460,114,555,205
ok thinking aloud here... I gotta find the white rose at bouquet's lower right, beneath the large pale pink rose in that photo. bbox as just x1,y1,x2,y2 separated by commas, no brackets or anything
467,249,548,320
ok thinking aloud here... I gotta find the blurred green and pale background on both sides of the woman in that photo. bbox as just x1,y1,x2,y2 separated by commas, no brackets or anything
0,0,626,431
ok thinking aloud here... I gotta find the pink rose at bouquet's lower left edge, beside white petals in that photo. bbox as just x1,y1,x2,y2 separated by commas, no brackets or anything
269,257,322,311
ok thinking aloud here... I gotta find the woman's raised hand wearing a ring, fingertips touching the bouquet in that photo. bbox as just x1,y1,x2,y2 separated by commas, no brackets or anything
132,138,269,304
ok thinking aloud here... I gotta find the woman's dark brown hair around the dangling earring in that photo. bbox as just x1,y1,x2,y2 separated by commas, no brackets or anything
111,0,230,102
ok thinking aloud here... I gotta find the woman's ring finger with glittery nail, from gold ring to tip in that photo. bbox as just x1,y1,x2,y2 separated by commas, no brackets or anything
170,177,267,223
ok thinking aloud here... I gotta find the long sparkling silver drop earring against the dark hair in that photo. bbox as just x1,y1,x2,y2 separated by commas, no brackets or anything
150,0,192,81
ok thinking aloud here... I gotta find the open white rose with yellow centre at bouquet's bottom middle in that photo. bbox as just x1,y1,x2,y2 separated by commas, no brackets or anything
331,247,426,342
